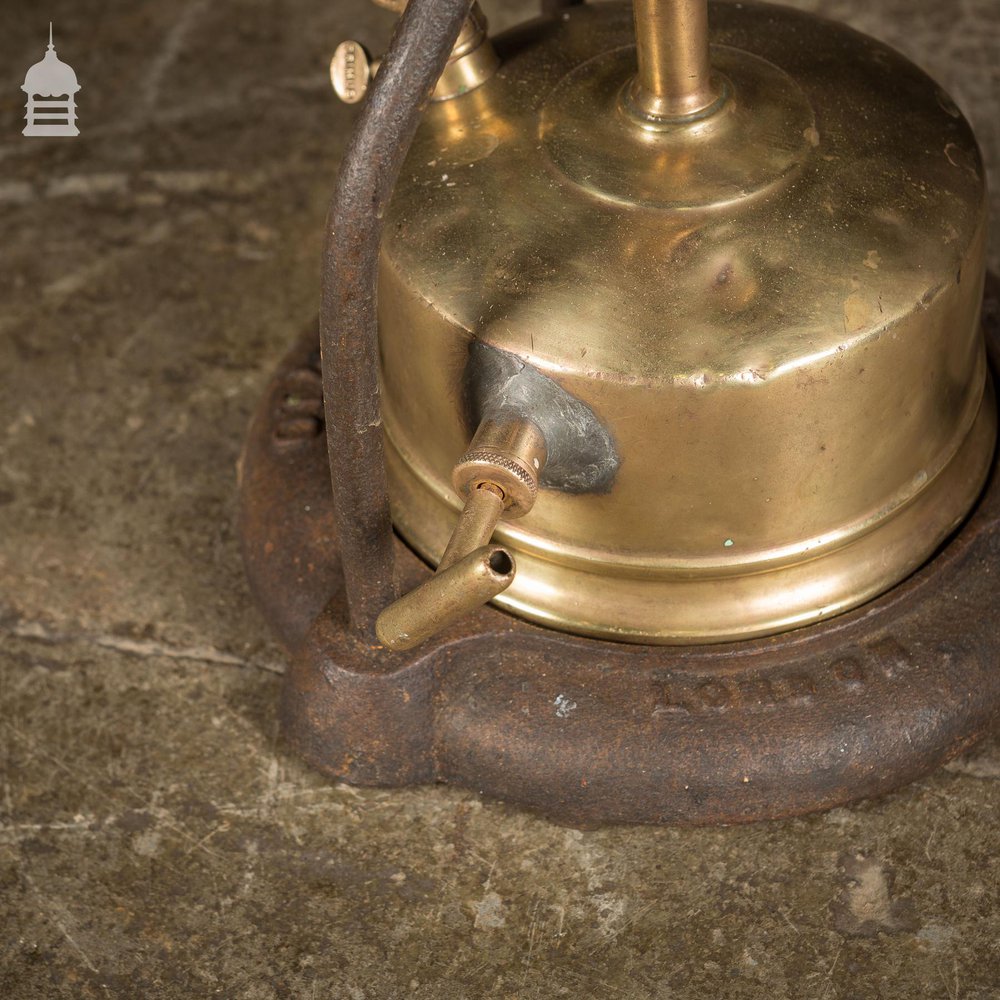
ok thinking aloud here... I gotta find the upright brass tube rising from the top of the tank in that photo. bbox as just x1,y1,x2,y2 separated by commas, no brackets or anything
632,0,718,119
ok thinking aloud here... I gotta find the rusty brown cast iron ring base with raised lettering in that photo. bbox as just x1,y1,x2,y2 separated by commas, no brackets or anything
241,316,1000,826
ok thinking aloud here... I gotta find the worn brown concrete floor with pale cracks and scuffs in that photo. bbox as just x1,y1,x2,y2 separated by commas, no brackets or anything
0,0,1000,1000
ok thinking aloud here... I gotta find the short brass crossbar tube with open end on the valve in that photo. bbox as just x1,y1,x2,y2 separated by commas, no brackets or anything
375,545,515,652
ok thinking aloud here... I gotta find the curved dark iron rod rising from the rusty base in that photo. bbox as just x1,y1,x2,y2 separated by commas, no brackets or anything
320,0,472,642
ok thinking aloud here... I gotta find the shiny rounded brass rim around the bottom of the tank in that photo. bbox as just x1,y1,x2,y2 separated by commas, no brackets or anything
385,379,996,645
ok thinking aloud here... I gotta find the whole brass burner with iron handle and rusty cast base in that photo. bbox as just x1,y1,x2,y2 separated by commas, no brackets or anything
241,0,1000,824
